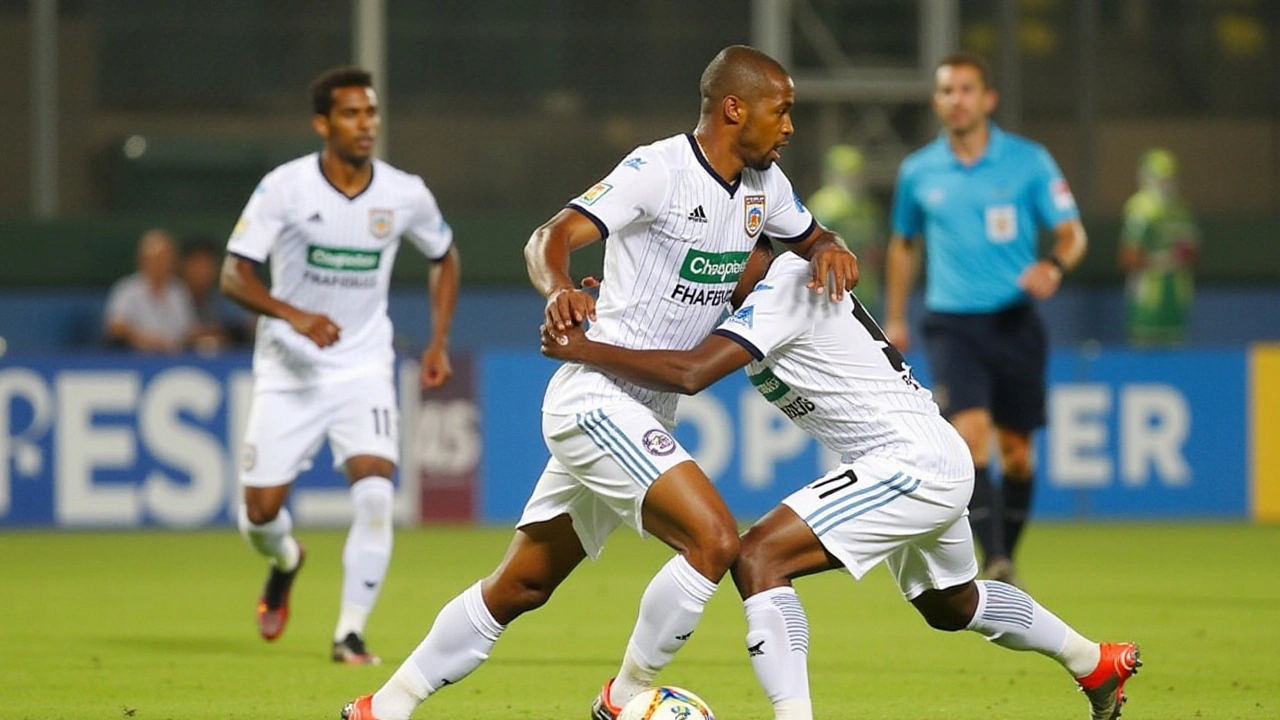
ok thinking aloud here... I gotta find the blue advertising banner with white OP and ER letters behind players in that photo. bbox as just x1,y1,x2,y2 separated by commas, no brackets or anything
479,350,1248,521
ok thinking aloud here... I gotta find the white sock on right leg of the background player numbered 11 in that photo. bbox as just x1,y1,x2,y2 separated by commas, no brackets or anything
333,478,396,641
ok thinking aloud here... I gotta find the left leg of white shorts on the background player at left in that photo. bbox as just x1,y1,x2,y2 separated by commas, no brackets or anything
239,388,329,488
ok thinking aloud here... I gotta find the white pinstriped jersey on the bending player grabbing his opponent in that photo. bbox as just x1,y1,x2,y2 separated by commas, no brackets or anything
716,252,973,479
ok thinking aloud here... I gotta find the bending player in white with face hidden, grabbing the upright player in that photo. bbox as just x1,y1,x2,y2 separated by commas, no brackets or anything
543,241,1140,720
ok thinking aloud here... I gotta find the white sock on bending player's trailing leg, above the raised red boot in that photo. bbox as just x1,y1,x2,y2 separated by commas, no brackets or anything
965,580,1102,678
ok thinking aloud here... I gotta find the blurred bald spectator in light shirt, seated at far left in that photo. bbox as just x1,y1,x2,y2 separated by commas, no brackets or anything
105,228,196,352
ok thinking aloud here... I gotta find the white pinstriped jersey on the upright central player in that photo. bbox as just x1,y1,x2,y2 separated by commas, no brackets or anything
543,135,814,423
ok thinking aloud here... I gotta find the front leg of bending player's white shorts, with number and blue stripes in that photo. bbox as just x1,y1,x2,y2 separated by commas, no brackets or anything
782,457,973,579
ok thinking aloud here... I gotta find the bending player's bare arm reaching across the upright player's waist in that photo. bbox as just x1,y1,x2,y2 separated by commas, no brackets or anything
541,325,751,395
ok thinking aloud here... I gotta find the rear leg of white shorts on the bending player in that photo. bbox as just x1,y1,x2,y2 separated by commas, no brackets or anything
886,483,978,600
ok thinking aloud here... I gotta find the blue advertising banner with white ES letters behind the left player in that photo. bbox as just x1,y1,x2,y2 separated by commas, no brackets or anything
0,354,404,528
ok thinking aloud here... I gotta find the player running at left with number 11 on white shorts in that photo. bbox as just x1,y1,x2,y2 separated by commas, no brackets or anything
221,68,460,665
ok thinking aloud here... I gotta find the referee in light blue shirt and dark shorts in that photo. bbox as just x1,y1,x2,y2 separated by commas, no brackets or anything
884,54,1085,582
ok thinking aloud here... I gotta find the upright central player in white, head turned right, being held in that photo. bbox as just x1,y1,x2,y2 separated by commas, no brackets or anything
343,46,858,720
